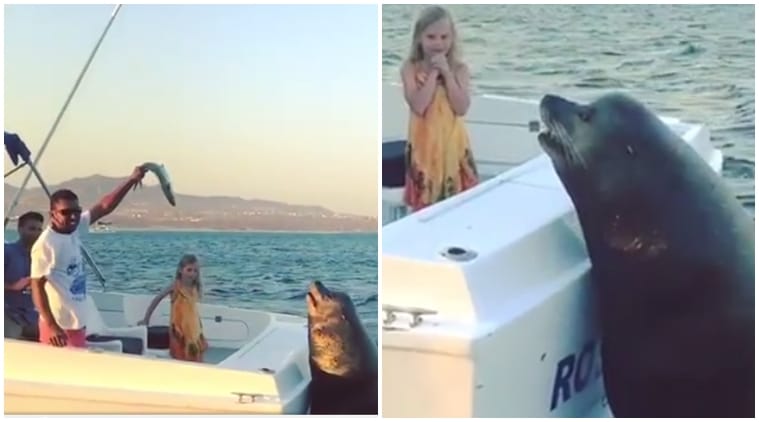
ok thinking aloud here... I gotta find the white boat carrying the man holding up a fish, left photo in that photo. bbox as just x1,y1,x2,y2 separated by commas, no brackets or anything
5,292,311,414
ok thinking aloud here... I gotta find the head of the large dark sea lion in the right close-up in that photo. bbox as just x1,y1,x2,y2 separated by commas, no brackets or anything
538,93,673,201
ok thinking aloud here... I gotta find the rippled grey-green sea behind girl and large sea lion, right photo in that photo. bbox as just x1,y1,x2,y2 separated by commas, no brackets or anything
382,5,755,214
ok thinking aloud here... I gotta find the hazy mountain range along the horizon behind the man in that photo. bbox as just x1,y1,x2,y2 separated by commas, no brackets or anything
5,175,377,232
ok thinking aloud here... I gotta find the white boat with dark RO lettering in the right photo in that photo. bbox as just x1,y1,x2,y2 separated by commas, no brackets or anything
381,84,722,418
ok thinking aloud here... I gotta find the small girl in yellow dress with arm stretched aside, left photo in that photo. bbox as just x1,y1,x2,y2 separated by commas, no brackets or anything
138,255,208,362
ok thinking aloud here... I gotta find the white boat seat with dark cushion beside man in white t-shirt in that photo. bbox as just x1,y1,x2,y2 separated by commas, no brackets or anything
86,295,148,355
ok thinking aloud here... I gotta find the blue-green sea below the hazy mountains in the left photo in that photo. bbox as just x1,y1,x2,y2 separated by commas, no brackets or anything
5,231,377,342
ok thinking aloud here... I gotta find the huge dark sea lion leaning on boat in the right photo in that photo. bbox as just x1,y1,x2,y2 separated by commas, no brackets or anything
538,94,755,418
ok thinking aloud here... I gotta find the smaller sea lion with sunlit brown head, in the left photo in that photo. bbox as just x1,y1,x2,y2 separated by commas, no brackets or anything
306,281,378,415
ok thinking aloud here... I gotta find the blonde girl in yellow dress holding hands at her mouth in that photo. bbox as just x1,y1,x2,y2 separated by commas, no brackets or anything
401,6,479,211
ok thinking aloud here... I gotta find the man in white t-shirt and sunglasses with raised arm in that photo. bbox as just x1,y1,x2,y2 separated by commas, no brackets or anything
30,166,146,347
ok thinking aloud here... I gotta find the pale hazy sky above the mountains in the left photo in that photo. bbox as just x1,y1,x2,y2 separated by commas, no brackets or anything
4,5,380,217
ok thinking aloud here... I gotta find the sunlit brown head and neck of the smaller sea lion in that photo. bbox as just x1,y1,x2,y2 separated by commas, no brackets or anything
306,281,365,376
